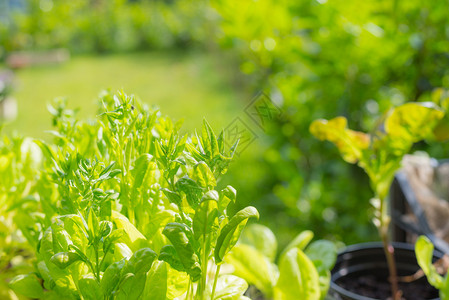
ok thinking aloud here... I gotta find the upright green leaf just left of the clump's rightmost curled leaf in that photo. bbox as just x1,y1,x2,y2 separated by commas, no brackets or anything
193,190,218,242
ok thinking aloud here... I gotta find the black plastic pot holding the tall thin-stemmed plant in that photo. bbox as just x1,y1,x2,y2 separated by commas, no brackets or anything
329,243,443,300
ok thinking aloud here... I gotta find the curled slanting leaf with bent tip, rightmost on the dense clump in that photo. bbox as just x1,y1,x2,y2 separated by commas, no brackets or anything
214,206,259,264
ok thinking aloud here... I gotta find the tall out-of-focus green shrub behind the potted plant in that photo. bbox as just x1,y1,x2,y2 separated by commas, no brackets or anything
213,0,449,242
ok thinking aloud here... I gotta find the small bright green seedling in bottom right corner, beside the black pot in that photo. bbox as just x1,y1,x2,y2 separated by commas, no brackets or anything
415,236,449,300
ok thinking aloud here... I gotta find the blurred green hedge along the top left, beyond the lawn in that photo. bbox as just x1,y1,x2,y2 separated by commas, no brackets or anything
0,0,214,53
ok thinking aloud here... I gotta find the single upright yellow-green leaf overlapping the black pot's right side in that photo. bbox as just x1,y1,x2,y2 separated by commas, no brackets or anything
415,236,443,289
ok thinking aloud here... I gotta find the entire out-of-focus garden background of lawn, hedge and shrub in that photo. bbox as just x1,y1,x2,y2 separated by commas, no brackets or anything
0,0,449,248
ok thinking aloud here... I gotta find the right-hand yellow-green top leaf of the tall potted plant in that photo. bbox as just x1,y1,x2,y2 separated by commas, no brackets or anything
385,102,444,147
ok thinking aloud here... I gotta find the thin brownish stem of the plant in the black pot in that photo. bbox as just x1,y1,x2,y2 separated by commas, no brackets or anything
379,198,401,300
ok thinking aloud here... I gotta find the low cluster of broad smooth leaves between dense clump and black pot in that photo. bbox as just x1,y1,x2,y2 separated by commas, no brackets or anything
227,224,337,300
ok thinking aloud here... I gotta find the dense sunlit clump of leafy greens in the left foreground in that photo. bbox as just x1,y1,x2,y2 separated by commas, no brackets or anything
9,93,259,300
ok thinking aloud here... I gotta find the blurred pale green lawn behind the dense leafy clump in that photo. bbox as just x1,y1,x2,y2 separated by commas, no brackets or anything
5,52,249,138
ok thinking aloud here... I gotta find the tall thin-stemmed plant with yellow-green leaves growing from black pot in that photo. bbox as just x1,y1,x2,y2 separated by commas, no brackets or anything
310,102,444,299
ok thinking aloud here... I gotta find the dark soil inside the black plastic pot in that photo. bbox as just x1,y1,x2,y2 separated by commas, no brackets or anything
336,275,438,300
